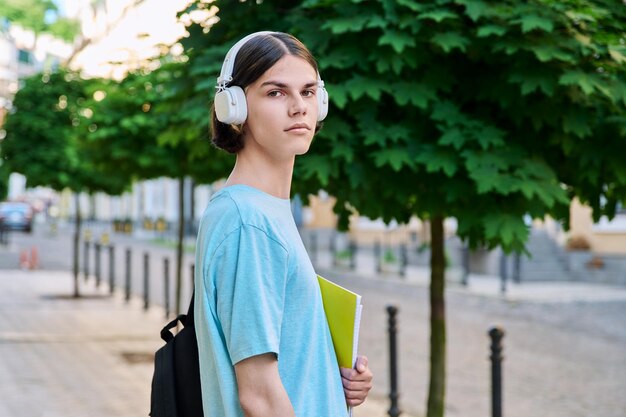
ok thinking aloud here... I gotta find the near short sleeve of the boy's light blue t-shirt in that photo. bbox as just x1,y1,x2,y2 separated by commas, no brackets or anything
209,225,288,365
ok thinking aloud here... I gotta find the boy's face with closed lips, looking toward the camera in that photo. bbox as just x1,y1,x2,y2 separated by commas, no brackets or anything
244,55,318,162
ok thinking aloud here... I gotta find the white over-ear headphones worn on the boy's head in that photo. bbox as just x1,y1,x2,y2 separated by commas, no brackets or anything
214,31,328,124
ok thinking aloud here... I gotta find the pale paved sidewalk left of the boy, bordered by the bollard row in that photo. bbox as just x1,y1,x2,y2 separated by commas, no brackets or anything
0,270,406,417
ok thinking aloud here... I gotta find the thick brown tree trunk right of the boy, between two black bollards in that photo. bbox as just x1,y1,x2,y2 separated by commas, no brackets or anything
426,216,446,417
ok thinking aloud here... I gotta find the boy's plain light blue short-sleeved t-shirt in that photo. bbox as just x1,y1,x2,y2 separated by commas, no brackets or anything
194,185,347,417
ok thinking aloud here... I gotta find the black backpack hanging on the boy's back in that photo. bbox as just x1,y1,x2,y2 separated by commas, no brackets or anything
150,296,204,417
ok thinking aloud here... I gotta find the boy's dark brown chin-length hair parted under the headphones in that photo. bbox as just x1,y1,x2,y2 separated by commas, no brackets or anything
211,32,321,153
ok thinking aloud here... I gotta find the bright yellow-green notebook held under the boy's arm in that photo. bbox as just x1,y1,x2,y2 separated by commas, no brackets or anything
317,275,362,368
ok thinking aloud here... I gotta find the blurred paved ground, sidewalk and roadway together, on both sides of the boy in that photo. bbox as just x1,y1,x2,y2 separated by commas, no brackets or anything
0,225,626,417
